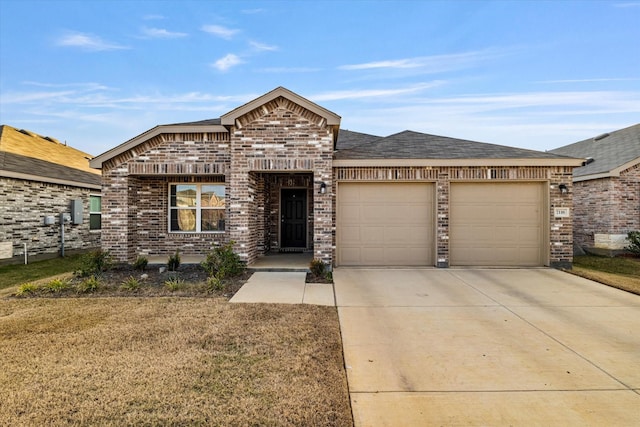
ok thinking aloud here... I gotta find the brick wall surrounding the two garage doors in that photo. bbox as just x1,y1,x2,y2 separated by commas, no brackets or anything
333,167,573,268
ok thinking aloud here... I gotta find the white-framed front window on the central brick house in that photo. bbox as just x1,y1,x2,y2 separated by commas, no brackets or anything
169,184,225,233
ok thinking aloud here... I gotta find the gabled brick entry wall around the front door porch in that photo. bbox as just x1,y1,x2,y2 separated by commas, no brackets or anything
228,97,334,263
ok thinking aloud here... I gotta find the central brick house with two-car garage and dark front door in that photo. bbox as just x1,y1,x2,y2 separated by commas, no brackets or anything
91,87,581,267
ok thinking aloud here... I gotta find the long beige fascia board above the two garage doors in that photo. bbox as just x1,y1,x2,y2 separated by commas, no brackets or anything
333,158,584,167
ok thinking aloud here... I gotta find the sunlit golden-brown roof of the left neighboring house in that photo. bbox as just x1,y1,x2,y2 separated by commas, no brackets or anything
0,125,100,189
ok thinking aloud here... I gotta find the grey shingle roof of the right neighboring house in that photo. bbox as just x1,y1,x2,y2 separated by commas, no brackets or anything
551,123,640,181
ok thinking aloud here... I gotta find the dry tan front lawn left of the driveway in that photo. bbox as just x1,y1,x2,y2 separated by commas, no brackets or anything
0,298,352,426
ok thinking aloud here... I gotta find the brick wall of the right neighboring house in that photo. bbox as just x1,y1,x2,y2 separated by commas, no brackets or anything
574,165,640,249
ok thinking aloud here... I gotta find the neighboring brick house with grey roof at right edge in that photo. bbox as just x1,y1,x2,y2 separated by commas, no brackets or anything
551,124,640,251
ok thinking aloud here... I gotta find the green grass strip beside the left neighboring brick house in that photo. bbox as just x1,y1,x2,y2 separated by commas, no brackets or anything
0,255,82,289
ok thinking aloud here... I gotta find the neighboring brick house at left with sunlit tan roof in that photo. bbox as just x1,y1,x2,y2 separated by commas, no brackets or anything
0,125,101,263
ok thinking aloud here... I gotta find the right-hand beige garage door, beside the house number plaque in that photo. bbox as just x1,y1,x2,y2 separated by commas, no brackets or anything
449,182,546,267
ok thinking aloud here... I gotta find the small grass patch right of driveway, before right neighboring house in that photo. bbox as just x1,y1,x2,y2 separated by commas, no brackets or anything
572,255,640,295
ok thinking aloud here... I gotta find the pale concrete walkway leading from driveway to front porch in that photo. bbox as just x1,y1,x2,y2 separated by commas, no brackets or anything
229,271,335,306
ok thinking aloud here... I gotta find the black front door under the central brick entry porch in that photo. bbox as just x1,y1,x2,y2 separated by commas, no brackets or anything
280,188,307,248
